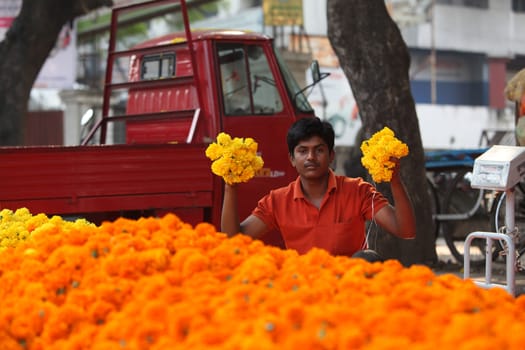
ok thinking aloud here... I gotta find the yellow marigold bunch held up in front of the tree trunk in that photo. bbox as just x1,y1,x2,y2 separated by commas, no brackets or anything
361,126,408,183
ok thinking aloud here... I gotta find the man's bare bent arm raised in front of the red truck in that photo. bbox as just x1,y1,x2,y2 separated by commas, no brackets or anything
221,184,268,238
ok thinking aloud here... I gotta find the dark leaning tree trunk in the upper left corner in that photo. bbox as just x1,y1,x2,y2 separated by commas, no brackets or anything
0,0,113,145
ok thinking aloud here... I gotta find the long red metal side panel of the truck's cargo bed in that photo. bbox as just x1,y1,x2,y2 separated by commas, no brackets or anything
0,144,213,213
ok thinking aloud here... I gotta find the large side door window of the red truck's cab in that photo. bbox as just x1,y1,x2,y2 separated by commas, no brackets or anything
217,44,283,115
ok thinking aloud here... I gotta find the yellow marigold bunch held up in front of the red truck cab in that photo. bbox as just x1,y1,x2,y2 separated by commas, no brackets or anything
206,132,264,184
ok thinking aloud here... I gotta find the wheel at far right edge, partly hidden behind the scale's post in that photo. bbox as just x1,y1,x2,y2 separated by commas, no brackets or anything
490,184,525,268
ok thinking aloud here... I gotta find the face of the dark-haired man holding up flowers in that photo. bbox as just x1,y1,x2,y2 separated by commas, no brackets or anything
290,136,334,179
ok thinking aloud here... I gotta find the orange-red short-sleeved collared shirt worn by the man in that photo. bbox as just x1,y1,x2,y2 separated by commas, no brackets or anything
252,171,388,256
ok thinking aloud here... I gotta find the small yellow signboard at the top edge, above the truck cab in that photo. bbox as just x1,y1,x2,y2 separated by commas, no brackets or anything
263,0,303,26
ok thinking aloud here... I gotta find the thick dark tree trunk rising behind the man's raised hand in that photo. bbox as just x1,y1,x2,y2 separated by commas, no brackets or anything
327,0,437,265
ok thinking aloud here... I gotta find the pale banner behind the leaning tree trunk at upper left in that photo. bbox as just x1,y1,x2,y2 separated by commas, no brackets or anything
0,0,77,89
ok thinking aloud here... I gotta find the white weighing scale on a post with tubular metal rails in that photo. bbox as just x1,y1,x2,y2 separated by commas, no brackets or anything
464,145,525,295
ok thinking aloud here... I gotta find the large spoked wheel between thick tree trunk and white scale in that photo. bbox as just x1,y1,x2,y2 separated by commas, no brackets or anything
441,169,490,266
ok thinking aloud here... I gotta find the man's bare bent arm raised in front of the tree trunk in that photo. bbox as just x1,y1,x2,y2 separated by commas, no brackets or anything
374,160,416,239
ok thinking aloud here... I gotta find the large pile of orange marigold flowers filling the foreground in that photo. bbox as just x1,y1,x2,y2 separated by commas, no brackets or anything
0,209,525,350
